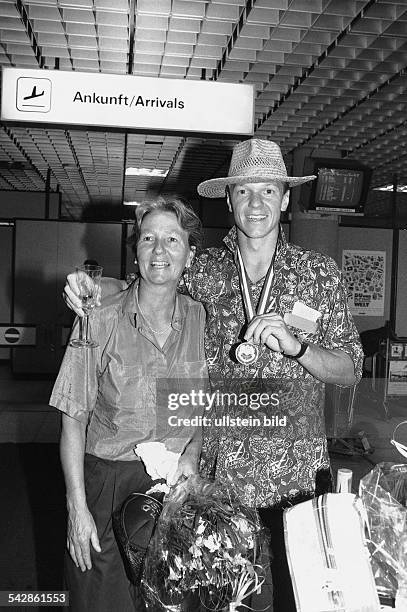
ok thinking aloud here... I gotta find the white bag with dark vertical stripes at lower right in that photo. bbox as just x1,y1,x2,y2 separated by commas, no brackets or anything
284,493,380,612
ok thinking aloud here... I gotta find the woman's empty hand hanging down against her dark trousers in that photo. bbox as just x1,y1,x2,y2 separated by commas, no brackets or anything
66,505,102,572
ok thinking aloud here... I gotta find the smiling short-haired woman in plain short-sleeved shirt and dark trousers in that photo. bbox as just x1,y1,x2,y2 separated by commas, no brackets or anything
50,198,207,612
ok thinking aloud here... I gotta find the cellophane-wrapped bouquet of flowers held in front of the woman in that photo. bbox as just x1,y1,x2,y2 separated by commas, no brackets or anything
142,476,268,611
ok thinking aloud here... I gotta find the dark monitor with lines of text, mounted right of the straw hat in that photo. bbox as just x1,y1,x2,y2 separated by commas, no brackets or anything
315,168,363,209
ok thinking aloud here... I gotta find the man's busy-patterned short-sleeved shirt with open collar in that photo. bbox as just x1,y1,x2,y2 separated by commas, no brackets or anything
184,228,363,507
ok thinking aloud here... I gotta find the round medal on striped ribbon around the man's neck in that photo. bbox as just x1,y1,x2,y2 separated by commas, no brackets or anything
234,238,275,365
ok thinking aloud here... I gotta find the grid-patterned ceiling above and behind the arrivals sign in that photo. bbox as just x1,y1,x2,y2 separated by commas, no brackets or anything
0,0,407,219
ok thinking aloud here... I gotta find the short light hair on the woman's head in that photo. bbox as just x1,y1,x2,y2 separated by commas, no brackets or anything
128,196,202,252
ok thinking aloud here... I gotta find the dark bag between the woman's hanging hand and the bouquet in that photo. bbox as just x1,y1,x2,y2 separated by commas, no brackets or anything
112,493,163,586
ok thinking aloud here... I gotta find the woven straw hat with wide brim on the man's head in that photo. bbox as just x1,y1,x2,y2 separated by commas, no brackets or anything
198,138,316,198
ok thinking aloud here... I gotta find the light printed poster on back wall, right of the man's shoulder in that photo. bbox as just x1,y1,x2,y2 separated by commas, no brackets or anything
342,249,386,317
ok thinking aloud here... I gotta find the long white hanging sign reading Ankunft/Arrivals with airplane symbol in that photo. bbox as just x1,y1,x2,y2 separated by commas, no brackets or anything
1,68,254,136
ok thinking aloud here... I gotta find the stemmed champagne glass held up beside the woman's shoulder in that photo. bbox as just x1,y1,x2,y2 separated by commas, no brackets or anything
69,264,103,348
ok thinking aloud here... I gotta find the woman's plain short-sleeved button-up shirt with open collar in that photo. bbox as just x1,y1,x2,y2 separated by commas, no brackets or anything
50,281,207,461
